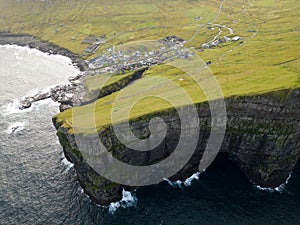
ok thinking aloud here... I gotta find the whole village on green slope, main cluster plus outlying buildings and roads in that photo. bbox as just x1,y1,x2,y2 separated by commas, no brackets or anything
82,23,242,74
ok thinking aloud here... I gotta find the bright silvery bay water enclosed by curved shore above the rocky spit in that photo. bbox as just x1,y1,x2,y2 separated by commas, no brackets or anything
0,45,80,98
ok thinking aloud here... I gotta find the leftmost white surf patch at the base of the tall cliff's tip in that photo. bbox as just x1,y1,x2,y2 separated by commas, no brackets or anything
108,189,137,214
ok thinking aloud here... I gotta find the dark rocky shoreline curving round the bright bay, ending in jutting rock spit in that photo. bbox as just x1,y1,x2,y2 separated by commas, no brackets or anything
0,32,89,112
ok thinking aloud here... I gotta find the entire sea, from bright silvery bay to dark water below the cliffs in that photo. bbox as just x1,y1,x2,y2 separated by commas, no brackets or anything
0,44,300,225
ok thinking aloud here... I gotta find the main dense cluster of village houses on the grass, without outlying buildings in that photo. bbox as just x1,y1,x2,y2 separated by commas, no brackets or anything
87,36,194,74
